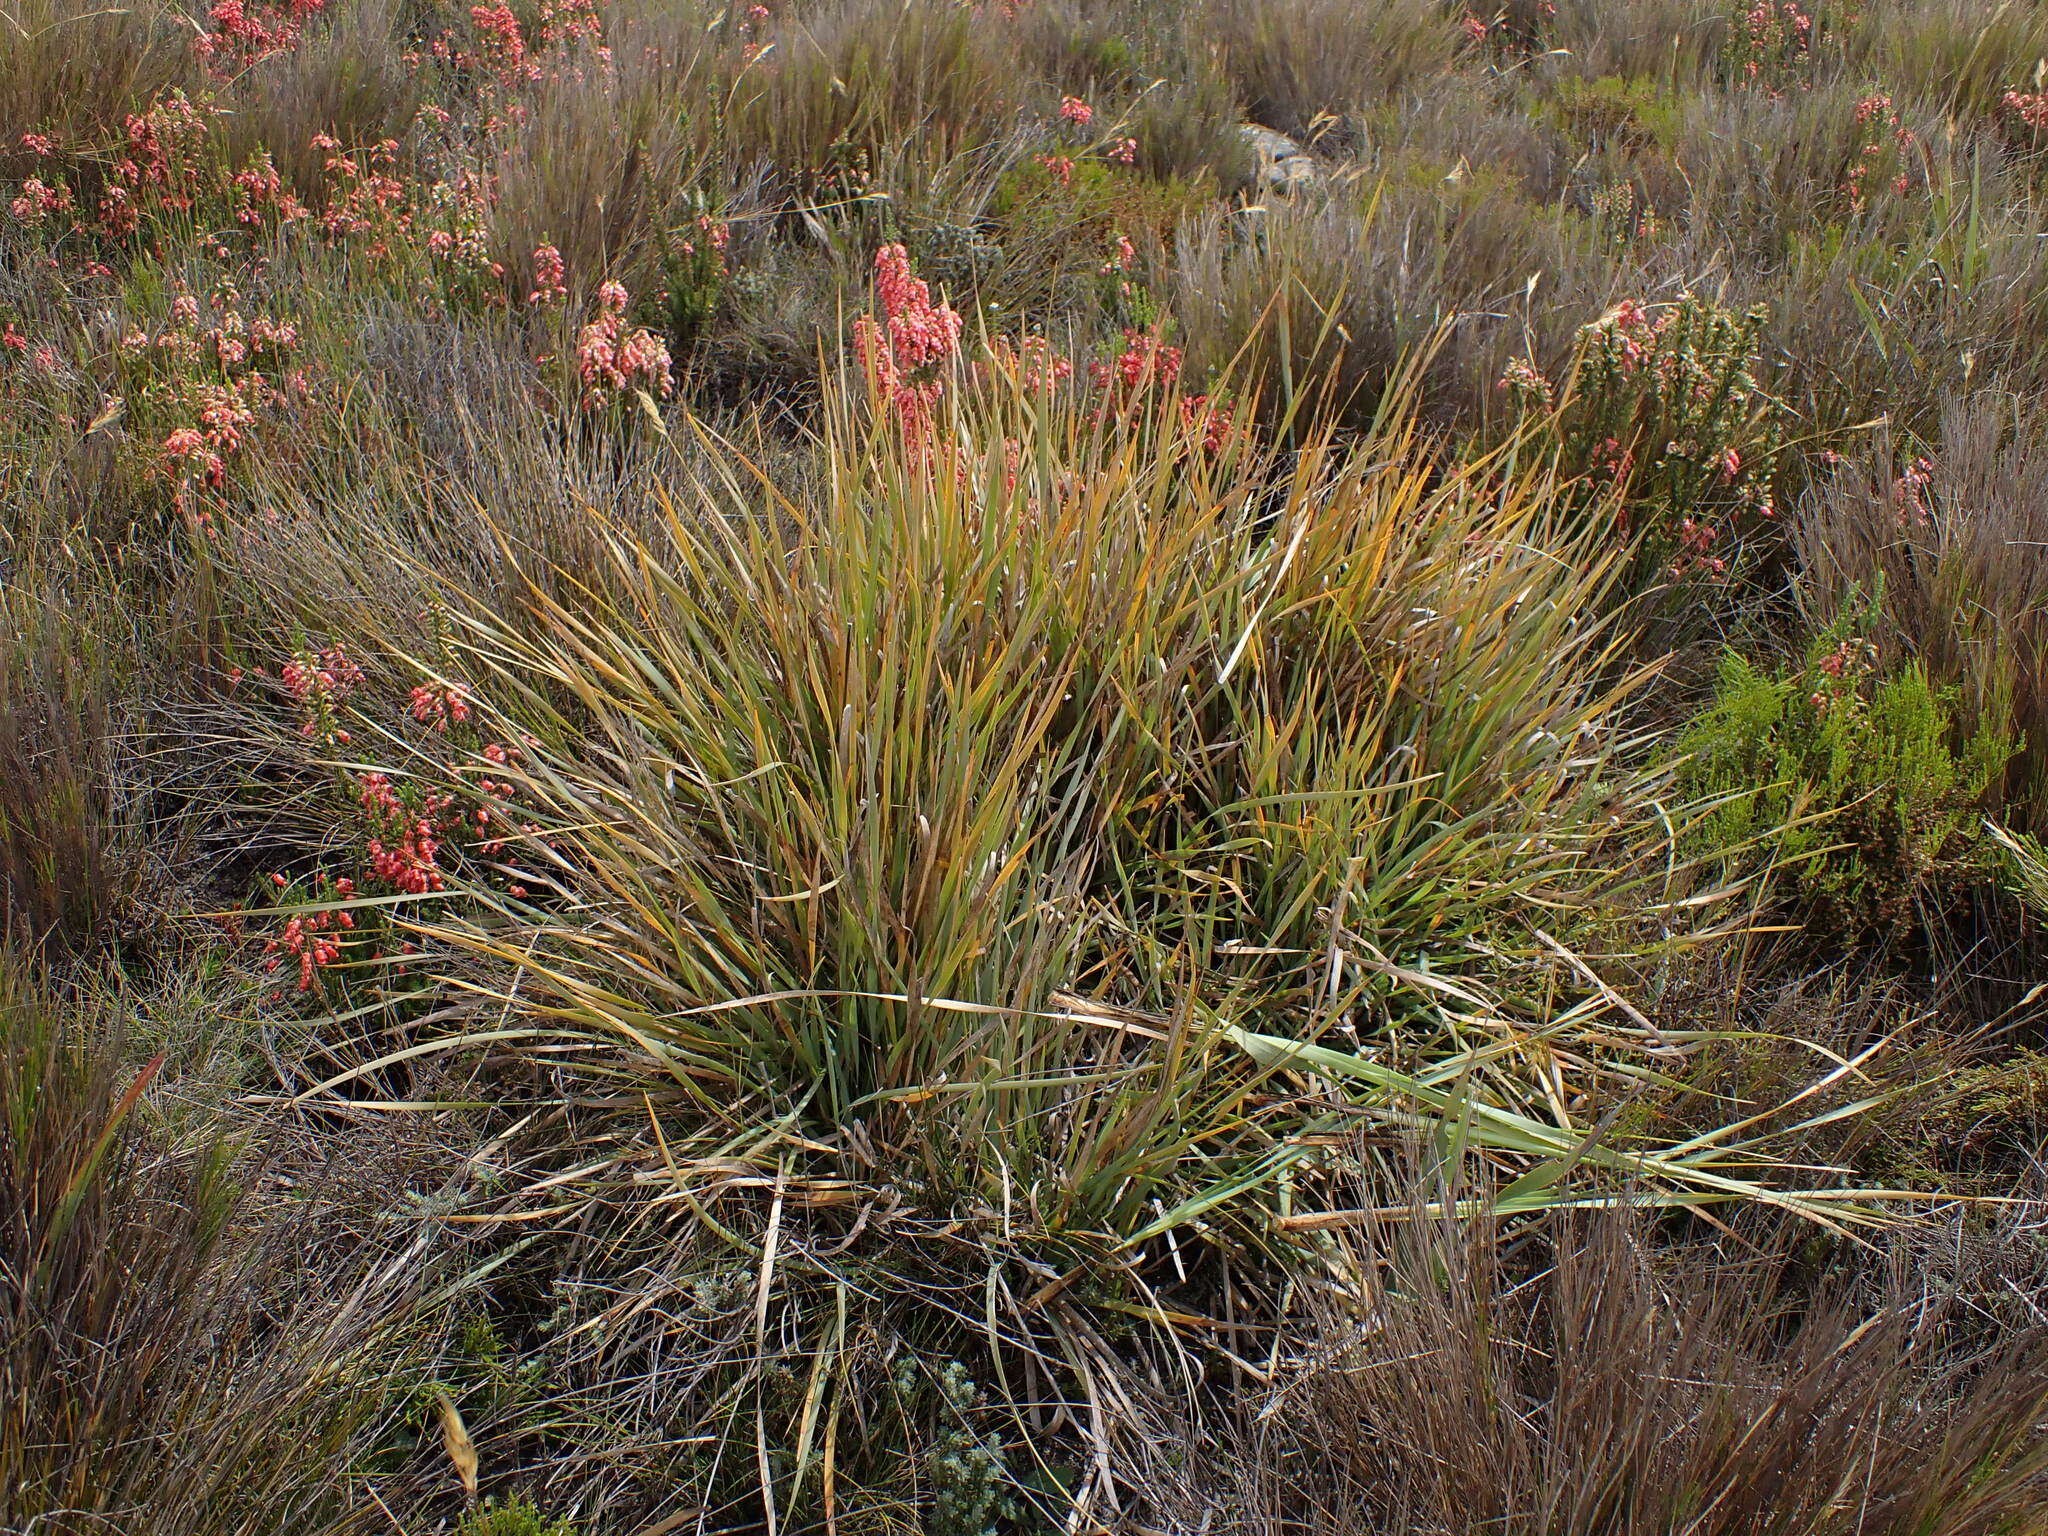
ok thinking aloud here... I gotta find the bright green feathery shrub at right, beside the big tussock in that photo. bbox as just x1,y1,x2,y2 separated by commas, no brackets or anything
1681,614,2017,932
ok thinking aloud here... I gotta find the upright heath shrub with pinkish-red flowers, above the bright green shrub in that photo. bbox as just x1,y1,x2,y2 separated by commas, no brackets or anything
1499,297,1780,575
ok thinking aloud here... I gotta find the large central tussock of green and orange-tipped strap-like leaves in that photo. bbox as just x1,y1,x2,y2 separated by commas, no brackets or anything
368,360,1875,1233
